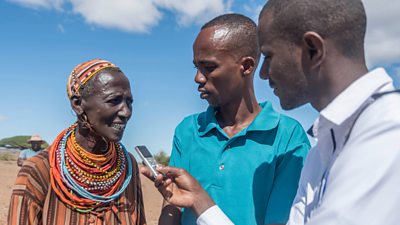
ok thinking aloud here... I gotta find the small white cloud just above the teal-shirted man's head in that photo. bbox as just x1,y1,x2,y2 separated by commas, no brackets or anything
156,0,232,25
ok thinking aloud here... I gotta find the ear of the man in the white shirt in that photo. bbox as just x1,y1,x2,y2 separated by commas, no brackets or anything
302,31,326,69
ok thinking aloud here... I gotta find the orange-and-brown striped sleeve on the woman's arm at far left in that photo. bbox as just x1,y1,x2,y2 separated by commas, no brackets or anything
7,153,49,225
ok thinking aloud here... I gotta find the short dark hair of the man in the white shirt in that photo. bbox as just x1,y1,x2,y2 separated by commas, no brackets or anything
260,0,367,58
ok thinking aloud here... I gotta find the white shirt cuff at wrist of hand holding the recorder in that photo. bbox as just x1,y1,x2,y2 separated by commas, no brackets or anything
196,205,233,225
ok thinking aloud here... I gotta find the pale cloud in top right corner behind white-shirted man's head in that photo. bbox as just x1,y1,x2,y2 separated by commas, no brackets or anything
363,0,400,66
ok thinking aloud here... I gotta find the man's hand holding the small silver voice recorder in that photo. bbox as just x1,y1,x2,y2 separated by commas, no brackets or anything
140,166,215,216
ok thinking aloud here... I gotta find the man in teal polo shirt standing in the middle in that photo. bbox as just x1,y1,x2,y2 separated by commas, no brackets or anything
160,14,310,225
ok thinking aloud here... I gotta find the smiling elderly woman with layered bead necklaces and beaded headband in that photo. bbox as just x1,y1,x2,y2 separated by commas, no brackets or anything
8,60,146,225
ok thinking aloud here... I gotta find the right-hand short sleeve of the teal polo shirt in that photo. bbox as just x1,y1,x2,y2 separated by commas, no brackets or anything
264,124,310,224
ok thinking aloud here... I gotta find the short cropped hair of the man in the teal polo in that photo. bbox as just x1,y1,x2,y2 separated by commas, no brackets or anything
201,13,260,62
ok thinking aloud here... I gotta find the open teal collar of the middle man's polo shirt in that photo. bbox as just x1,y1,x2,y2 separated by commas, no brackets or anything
198,102,280,136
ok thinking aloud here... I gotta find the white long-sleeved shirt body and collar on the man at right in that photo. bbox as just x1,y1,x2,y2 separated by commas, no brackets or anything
288,68,400,225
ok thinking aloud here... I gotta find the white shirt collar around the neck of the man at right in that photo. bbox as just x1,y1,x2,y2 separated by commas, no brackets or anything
320,68,392,125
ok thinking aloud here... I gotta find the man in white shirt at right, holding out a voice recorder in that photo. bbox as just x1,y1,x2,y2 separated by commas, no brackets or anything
141,0,400,225
